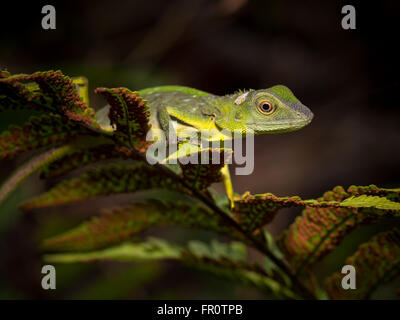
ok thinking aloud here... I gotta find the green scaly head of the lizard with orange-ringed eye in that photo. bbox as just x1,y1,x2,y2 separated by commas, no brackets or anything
215,85,313,134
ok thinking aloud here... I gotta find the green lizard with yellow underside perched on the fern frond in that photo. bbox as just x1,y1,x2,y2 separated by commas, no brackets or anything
96,85,313,205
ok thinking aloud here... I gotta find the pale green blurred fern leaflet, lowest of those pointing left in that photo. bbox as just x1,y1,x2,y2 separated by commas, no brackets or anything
44,238,298,299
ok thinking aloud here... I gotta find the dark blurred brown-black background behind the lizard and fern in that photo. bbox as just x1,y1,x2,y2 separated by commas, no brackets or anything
0,0,400,298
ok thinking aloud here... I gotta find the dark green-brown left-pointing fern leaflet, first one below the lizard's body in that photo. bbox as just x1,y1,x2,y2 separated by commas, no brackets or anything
21,162,190,210
